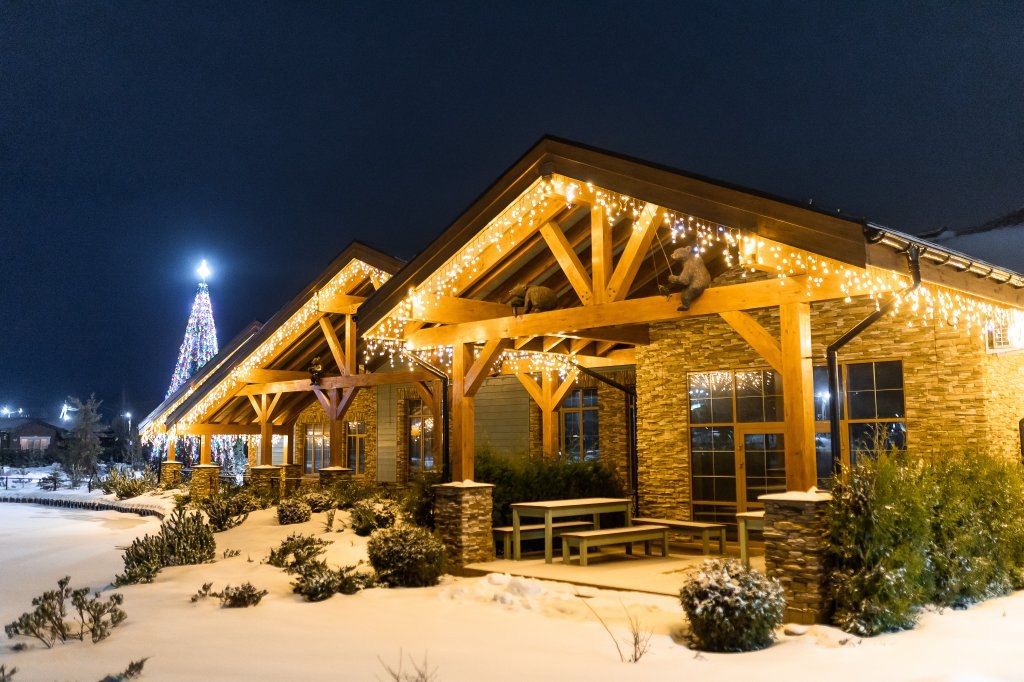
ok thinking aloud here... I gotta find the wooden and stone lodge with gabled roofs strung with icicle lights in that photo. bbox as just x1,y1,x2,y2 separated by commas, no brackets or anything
141,138,1024,561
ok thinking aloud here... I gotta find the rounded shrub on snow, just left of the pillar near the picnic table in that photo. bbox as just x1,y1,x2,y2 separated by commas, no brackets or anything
367,525,444,587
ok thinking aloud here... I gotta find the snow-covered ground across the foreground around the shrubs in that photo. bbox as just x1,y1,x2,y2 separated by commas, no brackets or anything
0,493,1024,682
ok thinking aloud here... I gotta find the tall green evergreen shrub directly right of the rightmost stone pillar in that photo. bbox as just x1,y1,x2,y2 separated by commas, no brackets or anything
828,451,932,636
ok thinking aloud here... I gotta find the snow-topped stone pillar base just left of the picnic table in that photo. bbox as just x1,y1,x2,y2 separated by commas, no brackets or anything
434,481,495,572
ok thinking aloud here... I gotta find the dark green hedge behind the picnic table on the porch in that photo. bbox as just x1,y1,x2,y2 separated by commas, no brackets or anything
475,452,623,525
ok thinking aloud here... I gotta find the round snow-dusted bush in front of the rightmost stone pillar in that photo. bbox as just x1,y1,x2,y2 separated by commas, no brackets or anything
679,559,785,651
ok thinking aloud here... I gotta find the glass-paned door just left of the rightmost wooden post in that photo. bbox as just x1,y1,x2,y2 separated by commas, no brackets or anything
736,424,785,511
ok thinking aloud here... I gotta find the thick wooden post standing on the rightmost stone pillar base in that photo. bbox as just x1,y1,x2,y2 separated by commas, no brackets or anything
779,303,817,491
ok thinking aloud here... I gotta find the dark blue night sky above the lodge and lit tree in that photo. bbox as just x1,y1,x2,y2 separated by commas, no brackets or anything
0,0,1024,419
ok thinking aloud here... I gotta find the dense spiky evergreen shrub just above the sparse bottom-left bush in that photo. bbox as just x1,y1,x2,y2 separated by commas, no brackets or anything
114,508,217,585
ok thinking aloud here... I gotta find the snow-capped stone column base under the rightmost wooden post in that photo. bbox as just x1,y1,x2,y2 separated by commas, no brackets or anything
758,493,833,625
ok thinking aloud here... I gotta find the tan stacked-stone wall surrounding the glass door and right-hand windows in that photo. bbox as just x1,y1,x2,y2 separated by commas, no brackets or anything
636,270,1024,518
